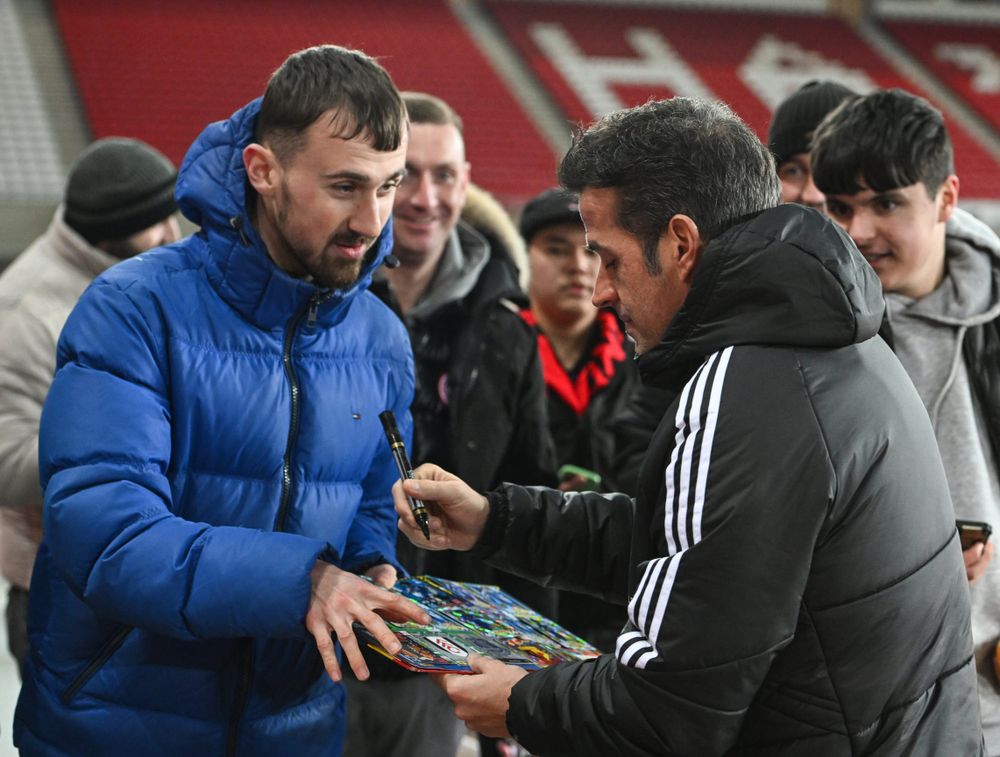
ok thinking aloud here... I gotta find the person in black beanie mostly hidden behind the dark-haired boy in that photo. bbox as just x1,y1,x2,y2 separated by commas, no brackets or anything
767,80,857,210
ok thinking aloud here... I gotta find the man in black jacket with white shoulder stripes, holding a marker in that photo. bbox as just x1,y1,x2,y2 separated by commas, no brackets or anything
394,98,983,757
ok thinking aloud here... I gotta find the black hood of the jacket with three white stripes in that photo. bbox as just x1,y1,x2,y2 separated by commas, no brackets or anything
638,204,885,388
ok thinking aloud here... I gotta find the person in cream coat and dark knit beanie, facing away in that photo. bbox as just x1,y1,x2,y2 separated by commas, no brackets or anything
0,137,180,680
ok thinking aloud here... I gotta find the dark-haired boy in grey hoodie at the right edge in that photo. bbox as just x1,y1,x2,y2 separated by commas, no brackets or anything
812,89,1000,755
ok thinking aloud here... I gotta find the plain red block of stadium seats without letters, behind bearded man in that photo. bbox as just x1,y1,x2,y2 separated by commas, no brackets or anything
53,0,556,204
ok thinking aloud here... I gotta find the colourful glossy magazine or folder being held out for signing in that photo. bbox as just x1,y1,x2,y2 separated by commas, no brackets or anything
354,576,600,673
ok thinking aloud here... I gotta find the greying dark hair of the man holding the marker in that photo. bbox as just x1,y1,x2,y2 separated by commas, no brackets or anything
559,97,781,273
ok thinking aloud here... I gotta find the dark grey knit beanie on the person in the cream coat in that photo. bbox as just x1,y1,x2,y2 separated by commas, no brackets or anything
63,137,177,244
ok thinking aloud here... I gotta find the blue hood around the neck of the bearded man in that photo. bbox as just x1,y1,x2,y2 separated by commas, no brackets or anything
177,98,392,329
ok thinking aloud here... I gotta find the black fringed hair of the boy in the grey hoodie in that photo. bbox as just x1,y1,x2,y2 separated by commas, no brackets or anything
811,89,955,197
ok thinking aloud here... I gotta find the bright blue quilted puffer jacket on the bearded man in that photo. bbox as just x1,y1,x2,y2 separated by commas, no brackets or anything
14,97,413,757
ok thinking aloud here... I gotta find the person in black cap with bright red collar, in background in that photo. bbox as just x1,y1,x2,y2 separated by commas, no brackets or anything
520,188,640,651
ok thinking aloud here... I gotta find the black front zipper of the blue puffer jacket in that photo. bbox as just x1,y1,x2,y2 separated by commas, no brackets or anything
226,292,333,757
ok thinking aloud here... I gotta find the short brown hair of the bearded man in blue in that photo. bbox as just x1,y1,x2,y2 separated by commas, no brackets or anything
254,45,406,161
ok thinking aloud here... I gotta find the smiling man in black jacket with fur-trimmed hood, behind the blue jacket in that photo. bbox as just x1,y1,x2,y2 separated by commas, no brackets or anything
344,92,555,757
